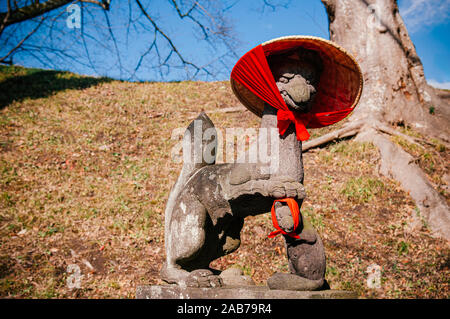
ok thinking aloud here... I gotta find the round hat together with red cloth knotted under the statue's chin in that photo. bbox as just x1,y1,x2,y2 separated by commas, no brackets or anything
231,37,362,141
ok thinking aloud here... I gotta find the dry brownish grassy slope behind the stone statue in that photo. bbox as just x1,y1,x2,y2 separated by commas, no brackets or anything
0,67,450,298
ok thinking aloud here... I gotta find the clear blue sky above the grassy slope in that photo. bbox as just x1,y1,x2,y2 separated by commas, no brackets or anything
0,0,450,88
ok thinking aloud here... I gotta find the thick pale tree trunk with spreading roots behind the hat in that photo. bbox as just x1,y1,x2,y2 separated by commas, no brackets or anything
314,0,450,240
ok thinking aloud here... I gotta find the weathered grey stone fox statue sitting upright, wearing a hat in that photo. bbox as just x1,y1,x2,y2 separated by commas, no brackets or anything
161,49,325,290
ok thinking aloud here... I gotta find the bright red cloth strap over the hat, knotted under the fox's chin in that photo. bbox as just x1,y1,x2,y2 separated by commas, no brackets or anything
231,41,353,141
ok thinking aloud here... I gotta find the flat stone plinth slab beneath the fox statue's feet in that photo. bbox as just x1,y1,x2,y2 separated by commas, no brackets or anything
136,285,357,299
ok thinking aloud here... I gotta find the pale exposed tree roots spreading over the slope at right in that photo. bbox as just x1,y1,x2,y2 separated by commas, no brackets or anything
303,122,450,240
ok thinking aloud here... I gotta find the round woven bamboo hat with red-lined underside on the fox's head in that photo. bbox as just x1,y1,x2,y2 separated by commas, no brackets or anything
230,35,363,128
